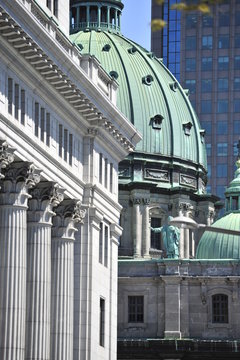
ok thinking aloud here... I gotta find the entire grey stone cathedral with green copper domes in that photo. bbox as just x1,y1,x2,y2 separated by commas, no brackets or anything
70,0,240,360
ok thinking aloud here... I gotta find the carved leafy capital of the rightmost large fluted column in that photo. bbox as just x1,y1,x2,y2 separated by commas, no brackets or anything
52,200,86,240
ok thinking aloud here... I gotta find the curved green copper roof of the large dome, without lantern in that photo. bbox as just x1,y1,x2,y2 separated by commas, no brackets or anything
71,30,207,169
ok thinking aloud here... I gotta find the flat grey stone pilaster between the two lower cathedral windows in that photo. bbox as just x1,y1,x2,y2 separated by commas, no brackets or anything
162,276,181,339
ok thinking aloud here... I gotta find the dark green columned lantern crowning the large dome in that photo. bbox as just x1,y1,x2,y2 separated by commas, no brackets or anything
70,0,124,33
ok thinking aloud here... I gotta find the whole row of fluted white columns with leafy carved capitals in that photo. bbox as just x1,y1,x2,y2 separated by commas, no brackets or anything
0,141,85,360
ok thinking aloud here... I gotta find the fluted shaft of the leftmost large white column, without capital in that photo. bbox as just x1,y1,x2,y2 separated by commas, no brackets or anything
0,205,26,360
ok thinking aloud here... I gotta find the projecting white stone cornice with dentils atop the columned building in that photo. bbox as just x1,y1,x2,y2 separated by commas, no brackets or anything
0,0,140,154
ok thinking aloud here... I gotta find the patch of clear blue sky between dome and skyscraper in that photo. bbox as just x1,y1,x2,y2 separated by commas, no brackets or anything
121,0,151,50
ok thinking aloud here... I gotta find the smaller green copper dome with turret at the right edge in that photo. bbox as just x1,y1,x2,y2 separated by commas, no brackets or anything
197,155,240,259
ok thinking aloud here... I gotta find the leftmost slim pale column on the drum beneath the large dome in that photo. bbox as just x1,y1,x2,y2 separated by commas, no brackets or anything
131,197,142,257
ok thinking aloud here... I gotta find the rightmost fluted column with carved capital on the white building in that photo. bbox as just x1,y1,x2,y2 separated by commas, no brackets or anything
51,200,85,360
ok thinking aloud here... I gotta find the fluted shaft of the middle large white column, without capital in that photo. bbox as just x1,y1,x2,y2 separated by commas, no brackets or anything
25,223,51,360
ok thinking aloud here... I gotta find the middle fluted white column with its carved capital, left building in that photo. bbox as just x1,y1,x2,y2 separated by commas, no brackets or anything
25,182,64,360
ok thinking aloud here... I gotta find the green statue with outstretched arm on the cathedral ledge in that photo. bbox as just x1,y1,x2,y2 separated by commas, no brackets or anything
151,216,180,259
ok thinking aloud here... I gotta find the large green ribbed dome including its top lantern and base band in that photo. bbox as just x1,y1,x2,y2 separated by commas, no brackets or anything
71,0,207,192
